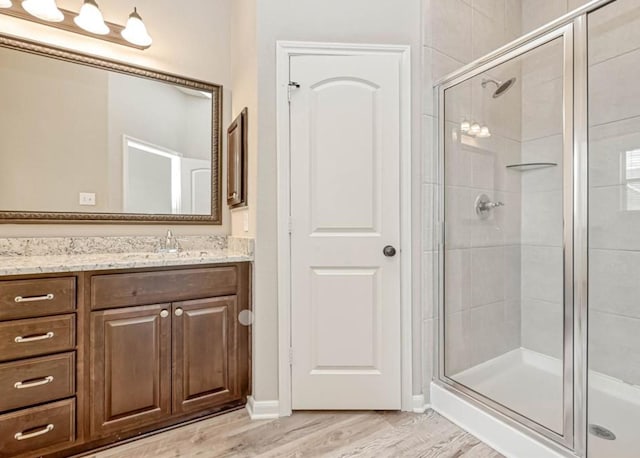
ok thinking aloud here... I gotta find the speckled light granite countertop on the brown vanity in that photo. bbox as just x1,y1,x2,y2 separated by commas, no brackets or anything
0,238,253,276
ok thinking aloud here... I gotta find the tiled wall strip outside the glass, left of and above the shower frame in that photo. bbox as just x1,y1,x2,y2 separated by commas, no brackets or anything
422,0,522,394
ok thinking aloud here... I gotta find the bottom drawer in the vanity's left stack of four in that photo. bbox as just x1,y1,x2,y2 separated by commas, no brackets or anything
0,399,76,458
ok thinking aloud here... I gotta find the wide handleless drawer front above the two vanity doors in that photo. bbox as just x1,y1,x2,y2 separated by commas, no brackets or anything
91,266,238,310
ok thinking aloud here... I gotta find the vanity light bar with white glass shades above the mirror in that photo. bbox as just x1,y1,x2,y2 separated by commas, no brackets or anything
0,0,153,49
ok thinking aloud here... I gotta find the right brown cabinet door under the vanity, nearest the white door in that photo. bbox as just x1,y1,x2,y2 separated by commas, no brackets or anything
173,296,240,414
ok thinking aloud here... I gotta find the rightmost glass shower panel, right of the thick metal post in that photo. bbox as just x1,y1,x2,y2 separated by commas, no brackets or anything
587,0,640,458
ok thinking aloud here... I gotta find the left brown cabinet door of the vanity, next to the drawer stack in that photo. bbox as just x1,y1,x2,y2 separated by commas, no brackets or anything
90,304,171,437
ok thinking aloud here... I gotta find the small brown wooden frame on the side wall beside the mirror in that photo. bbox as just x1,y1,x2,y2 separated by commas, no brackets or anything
227,108,249,209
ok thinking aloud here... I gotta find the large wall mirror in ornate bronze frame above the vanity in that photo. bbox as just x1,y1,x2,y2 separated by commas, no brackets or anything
0,35,222,224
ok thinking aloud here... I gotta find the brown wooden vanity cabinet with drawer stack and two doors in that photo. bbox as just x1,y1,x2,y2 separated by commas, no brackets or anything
0,255,251,457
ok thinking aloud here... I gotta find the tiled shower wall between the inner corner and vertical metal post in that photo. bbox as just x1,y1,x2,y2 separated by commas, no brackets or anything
519,38,564,358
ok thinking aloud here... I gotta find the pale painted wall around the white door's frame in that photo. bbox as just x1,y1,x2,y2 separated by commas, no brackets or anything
250,0,421,400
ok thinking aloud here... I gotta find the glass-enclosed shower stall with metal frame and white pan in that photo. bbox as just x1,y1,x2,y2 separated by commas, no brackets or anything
435,0,640,458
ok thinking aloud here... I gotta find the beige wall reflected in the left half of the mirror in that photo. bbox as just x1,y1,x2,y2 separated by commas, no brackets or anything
0,48,109,212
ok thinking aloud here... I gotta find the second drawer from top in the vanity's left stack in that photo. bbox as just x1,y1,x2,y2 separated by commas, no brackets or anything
0,315,76,361
